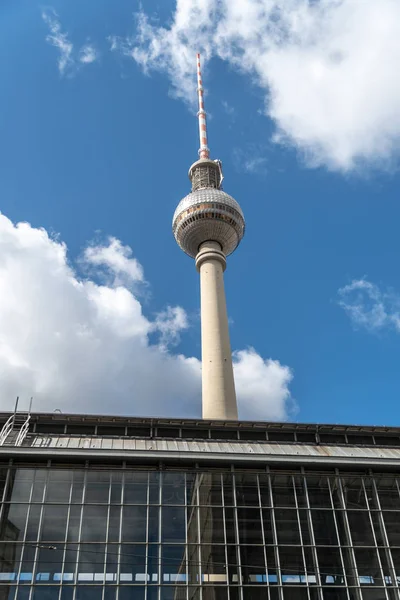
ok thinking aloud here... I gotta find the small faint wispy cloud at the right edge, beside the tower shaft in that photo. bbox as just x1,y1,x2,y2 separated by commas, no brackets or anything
338,279,400,333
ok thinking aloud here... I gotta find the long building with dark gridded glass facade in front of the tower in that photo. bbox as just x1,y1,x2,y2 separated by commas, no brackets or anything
0,416,400,600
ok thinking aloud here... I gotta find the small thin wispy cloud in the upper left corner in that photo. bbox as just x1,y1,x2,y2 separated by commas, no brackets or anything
42,9,98,76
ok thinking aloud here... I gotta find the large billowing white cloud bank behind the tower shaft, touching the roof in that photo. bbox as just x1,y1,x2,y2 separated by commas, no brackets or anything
0,214,292,419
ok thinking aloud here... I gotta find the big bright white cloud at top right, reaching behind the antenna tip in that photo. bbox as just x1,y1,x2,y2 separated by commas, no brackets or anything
110,0,400,171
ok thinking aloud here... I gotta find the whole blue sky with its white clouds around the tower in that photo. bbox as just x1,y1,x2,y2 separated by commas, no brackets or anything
0,0,400,425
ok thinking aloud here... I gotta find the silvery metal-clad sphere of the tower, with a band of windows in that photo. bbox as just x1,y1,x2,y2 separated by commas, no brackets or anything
172,188,245,258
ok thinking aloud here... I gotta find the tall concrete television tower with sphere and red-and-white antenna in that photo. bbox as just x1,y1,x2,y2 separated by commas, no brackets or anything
172,54,245,420
